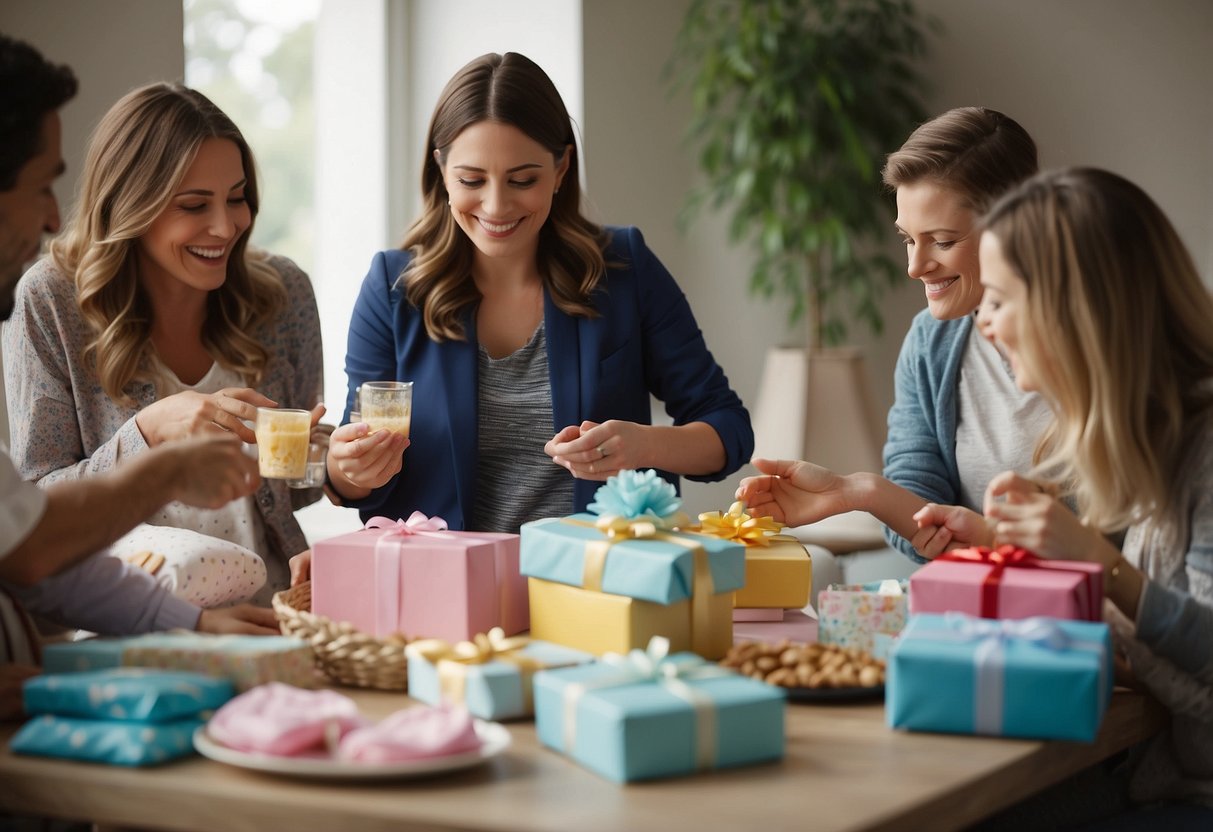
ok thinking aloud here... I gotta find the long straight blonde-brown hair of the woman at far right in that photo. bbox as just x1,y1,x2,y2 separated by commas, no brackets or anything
981,167,1213,531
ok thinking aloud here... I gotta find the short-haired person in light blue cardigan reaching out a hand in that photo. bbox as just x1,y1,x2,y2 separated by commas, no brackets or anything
738,107,1048,560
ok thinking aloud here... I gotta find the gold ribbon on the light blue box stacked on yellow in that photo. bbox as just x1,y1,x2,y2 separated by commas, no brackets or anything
564,514,716,653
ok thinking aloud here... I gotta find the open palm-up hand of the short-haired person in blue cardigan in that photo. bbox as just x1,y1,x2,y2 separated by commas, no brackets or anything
736,458,854,526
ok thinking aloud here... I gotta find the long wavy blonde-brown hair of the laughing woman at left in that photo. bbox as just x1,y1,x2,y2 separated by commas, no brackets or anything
50,84,286,401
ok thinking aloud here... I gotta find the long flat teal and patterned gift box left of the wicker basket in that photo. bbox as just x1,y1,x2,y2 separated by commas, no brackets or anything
42,632,317,691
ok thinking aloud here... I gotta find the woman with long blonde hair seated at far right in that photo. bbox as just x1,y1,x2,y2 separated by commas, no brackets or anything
918,169,1213,828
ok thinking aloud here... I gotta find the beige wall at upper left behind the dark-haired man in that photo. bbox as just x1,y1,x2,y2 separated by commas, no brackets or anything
0,0,186,443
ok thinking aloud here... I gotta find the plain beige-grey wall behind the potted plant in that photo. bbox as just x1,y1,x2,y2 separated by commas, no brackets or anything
582,0,1213,509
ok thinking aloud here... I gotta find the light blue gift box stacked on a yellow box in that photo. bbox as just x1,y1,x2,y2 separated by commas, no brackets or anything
519,514,746,604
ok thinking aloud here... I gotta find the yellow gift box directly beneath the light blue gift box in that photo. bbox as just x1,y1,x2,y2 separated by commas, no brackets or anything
528,577,733,659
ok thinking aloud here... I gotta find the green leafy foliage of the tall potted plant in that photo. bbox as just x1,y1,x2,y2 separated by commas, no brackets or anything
666,0,933,347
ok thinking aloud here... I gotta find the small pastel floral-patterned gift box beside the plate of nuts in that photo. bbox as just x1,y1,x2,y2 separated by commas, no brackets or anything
818,581,910,653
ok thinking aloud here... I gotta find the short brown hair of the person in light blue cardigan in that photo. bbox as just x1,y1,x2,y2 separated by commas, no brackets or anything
881,107,1038,215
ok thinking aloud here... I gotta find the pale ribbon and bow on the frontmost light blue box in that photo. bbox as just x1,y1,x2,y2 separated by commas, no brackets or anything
562,636,735,771
